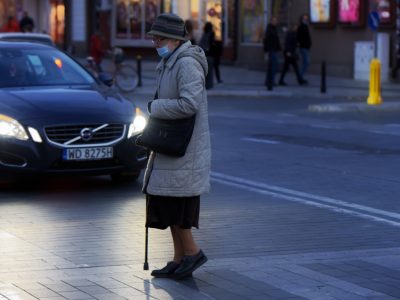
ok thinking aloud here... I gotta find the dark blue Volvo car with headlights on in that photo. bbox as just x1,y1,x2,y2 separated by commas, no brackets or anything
0,41,147,179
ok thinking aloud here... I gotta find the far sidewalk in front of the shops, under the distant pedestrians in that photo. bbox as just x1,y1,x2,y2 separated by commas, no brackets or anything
92,56,400,112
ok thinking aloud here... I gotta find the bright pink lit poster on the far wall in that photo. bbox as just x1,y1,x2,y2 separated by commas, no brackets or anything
338,0,365,27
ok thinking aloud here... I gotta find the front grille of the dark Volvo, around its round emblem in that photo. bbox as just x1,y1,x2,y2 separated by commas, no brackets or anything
45,124,125,146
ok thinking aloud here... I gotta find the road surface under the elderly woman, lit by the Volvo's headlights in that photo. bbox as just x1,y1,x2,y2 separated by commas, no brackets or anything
0,97,400,299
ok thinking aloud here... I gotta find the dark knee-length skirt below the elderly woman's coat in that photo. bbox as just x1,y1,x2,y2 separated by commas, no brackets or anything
146,195,200,229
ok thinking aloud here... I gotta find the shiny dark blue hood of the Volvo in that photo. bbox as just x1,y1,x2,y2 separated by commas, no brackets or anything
0,88,135,123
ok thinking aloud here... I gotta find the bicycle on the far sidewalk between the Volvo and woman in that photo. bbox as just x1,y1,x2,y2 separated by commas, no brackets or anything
86,48,139,93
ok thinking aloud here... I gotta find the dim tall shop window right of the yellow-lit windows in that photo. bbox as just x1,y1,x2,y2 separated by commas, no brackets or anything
240,0,265,43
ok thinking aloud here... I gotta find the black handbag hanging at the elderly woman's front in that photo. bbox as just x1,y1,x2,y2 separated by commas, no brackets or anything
136,115,196,157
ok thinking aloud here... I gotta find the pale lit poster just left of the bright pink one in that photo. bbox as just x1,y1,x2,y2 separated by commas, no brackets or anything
310,0,335,27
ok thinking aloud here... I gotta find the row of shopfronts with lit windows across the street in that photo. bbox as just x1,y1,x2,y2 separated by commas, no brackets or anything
0,0,400,77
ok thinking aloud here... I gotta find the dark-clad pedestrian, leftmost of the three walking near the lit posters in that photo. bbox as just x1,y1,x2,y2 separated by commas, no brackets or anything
263,17,281,90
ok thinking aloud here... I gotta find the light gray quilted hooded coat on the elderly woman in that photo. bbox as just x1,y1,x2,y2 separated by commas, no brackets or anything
143,41,211,197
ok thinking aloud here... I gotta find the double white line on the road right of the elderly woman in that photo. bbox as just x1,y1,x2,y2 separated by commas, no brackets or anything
211,172,400,227
